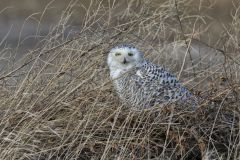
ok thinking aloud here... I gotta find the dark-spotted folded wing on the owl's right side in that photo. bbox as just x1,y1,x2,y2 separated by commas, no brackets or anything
133,61,195,103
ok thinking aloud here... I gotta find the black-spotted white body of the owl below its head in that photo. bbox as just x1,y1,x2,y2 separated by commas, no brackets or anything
114,60,197,108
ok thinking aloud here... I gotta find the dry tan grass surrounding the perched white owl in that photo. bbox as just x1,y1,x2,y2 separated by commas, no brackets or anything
0,0,240,160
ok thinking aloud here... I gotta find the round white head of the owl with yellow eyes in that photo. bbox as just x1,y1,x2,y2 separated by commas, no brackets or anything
107,44,143,75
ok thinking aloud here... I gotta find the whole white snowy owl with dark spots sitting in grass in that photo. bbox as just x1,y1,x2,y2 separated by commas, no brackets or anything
107,45,197,109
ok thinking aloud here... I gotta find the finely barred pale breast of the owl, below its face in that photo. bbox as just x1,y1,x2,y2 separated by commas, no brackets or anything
114,70,164,108
